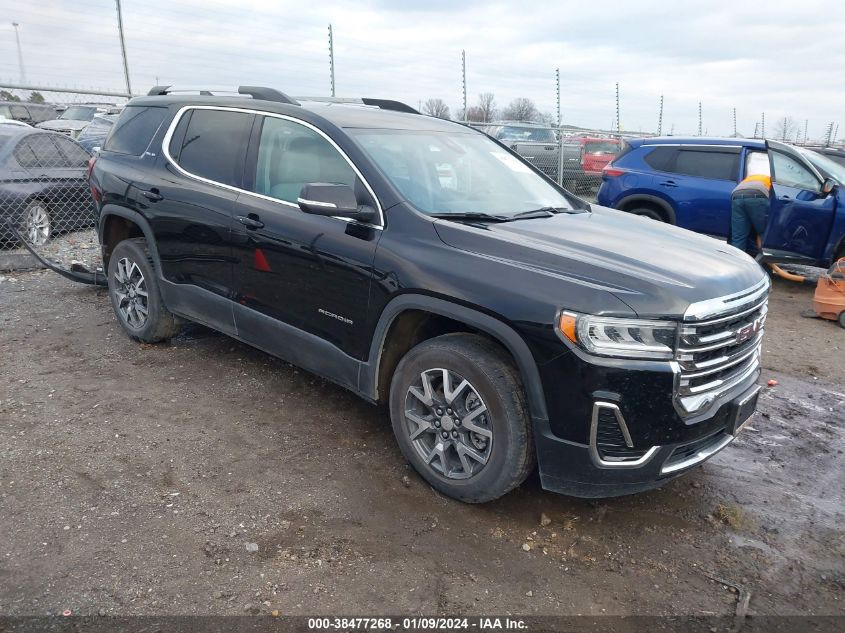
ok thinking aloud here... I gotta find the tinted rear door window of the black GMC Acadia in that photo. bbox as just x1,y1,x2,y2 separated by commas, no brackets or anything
170,110,254,187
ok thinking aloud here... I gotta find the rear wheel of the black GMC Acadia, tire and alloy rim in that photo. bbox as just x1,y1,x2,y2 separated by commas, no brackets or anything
108,238,180,343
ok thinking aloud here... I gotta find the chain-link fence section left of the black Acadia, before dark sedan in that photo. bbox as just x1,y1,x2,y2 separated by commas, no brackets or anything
0,130,100,270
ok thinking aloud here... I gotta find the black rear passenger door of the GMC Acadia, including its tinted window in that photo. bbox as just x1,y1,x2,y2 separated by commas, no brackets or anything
147,106,255,332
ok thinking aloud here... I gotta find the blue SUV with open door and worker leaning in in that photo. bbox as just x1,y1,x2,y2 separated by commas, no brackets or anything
597,137,845,266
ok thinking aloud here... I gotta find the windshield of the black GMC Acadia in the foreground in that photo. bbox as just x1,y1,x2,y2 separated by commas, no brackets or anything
349,129,573,216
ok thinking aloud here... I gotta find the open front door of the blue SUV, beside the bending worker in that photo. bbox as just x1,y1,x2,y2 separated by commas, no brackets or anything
763,141,836,260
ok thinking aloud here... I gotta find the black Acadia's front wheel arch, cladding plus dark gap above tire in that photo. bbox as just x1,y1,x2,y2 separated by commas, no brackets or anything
359,293,548,420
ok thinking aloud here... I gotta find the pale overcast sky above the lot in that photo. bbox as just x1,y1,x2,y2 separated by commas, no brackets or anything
0,0,845,138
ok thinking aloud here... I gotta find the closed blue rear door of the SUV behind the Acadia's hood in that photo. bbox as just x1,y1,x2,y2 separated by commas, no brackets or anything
646,145,741,237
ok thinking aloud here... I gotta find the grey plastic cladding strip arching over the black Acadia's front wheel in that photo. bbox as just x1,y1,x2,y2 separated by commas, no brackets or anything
358,293,548,421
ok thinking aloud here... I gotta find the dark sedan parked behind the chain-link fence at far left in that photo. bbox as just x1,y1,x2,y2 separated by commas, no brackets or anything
0,125,96,246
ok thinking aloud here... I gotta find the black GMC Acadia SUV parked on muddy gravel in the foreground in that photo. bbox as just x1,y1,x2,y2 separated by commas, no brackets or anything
90,87,769,502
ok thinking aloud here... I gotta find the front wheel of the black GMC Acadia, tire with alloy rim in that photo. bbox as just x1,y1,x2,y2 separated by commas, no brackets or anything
390,333,535,503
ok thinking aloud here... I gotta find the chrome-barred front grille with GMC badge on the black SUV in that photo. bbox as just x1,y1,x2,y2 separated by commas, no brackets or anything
676,280,768,413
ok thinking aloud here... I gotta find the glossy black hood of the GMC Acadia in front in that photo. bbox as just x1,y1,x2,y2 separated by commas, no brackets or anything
435,205,765,318
